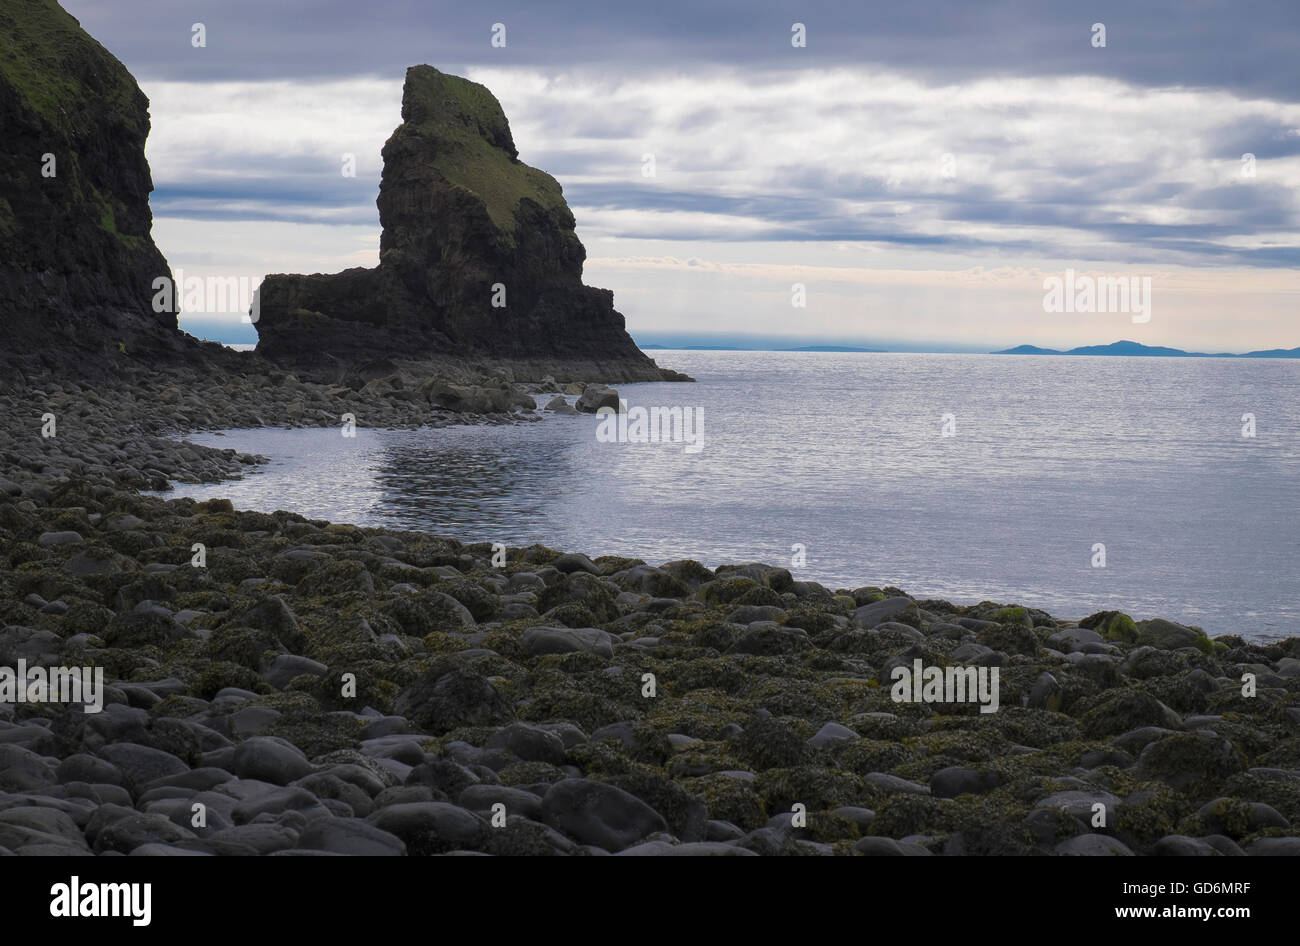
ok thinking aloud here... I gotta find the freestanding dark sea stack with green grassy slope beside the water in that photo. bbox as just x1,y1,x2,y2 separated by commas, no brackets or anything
256,66,662,379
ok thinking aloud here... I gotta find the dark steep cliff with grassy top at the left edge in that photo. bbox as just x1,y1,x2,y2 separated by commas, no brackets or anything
0,0,187,376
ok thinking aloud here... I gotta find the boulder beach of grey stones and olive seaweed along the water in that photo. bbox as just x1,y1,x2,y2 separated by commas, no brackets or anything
0,369,1300,856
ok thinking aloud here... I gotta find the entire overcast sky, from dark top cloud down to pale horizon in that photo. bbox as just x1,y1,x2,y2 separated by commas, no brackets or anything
64,0,1300,351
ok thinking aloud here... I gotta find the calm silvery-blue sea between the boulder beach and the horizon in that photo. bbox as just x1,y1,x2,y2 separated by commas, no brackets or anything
162,351,1300,638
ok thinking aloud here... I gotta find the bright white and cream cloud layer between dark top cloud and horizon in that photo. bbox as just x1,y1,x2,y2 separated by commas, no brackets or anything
137,69,1300,350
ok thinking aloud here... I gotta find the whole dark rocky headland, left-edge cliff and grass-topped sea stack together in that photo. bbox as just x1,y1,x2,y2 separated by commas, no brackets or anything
0,0,688,395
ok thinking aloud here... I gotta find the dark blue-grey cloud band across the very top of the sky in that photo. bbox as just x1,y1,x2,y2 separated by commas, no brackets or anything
65,0,1300,101
